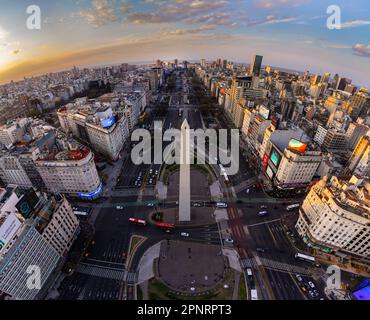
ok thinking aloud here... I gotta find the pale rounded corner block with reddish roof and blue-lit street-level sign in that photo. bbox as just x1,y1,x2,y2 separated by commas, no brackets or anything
0,123,102,199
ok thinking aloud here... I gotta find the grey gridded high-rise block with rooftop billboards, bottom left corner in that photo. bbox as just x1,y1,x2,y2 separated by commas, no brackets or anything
0,186,79,300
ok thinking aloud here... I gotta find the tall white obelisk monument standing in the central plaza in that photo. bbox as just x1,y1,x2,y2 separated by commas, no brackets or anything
179,119,191,222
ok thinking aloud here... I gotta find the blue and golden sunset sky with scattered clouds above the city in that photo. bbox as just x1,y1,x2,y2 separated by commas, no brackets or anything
0,0,370,87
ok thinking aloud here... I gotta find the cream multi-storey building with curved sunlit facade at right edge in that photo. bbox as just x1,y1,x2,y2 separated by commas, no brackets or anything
296,176,370,259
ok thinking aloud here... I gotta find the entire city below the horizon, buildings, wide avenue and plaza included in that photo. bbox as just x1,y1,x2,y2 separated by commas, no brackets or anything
0,55,370,300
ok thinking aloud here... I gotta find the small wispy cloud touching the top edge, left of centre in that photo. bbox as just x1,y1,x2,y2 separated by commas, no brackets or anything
77,0,118,28
